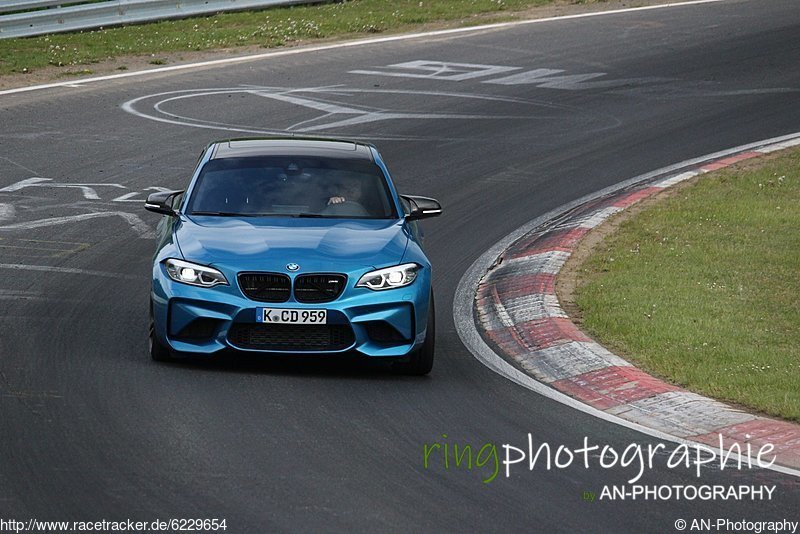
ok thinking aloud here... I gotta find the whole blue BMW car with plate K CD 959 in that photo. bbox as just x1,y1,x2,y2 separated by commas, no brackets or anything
145,138,442,375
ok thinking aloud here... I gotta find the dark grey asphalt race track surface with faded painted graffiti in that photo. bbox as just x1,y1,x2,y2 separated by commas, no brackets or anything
0,0,800,532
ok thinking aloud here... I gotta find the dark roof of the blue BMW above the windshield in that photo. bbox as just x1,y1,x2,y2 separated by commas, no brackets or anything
210,137,372,160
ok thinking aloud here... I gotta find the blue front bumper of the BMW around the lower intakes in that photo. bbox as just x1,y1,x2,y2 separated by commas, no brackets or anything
151,264,430,358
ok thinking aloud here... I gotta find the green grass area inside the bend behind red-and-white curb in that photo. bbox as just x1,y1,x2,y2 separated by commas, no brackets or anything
576,150,800,421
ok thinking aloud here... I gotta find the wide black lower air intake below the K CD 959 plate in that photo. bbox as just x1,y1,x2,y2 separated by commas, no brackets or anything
228,323,355,352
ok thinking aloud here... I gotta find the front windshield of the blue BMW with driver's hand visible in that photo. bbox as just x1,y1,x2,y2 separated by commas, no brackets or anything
187,156,397,219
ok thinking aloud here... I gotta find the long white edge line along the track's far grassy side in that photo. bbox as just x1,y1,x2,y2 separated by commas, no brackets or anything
0,0,726,98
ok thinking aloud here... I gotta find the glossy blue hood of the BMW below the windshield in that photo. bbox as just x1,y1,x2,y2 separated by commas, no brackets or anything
175,216,409,273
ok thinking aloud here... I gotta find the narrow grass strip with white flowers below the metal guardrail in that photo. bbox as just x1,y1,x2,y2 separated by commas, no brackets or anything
0,0,580,75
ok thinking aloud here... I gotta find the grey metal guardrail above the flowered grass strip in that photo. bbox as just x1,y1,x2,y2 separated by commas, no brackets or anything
0,0,330,39
